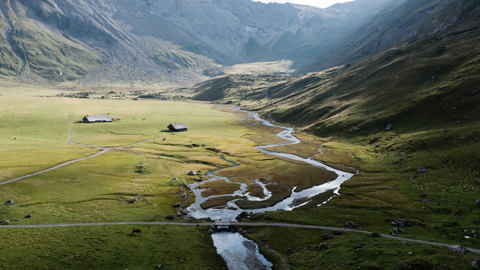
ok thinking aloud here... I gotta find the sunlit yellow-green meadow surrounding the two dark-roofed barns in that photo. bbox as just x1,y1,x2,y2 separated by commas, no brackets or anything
0,88,264,224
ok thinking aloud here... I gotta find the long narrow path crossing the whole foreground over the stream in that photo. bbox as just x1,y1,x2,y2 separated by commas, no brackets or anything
0,221,480,254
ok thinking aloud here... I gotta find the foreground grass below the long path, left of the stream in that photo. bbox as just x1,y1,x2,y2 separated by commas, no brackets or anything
0,226,225,270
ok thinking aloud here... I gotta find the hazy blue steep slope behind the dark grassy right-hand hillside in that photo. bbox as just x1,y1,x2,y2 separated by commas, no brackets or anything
310,0,476,71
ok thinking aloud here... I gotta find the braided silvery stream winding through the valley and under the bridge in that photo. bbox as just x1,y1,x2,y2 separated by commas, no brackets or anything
187,109,353,270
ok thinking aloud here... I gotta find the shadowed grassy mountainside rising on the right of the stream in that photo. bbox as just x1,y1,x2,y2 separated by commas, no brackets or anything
191,0,480,136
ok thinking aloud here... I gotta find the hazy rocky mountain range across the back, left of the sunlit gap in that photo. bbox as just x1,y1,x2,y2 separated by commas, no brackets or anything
0,0,394,85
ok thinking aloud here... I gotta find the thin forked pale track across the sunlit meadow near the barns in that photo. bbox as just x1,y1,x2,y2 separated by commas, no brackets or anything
0,116,161,186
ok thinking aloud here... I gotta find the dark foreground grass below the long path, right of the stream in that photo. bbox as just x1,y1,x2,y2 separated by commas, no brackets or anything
244,228,475,270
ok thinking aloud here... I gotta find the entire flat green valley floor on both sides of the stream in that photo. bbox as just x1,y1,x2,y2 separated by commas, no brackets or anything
0,88,480,269
